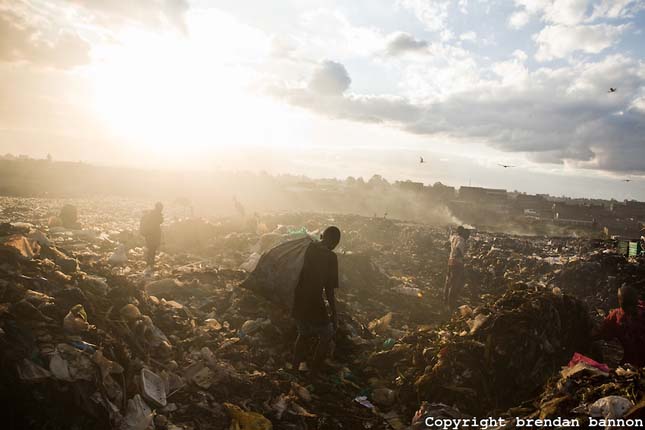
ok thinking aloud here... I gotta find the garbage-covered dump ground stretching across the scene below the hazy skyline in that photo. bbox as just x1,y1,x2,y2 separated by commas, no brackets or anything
0,198,645,430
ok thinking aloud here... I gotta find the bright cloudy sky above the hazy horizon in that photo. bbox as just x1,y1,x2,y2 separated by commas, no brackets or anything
0,0,645,200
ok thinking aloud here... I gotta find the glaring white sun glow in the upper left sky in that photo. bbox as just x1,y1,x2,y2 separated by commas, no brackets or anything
92,12,284,161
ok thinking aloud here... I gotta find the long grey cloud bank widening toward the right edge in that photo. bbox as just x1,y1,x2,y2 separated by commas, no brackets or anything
272,52,645,173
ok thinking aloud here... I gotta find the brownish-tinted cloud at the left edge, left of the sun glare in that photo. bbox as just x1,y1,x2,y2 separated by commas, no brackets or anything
0,10,90,69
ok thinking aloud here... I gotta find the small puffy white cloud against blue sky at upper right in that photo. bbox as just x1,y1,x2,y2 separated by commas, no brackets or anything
534,24,628,61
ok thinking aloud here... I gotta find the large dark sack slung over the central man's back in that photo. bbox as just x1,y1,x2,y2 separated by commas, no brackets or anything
242,236,313,309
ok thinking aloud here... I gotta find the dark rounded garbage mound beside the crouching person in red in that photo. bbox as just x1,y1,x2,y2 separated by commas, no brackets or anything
415,286,591,415
